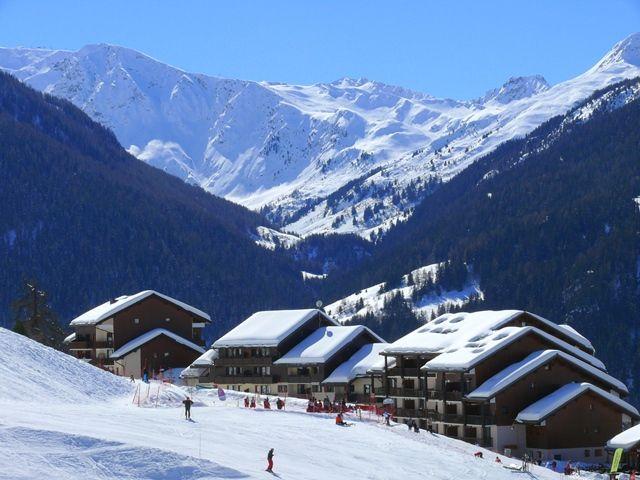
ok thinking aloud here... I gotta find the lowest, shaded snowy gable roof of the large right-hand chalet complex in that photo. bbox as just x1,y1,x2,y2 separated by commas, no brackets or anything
516,383,640,423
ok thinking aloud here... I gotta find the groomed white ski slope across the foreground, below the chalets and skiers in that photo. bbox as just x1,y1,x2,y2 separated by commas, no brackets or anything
0,329,592,480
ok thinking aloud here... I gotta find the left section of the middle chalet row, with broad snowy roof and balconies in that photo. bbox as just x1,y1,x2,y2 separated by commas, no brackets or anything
213,309,338,395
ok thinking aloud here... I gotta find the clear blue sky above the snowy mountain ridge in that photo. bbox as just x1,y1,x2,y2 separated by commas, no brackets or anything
0,0,640,99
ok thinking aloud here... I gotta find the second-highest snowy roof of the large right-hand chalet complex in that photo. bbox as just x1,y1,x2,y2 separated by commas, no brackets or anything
422,326,606,371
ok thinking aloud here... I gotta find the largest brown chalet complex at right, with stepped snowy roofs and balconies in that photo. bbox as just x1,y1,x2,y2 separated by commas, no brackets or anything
382,310,637,461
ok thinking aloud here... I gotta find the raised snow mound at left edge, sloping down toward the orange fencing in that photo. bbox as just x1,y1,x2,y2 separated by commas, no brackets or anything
0,328,132,403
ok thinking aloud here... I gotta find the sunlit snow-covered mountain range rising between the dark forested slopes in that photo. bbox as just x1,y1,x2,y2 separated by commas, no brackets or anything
0,34,640,237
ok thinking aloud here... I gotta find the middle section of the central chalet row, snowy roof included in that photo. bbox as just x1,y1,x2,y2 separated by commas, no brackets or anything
274,325,384,400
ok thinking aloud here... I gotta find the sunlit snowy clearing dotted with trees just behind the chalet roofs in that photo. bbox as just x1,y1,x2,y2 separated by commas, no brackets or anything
325,263,482,323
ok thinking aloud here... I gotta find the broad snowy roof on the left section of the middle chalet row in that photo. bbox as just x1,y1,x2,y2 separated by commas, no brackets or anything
213,309,338,348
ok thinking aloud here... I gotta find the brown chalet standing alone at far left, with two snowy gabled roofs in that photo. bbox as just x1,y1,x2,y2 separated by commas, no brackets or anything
65,290,211,378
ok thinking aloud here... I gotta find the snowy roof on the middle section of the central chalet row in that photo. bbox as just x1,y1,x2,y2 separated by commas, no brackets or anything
275,325,384,365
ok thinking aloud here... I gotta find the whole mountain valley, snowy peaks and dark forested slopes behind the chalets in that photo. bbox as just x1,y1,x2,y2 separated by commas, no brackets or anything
0,34,640,403
